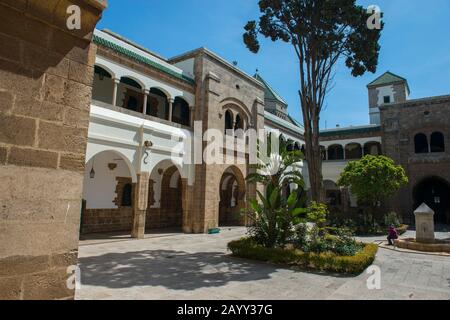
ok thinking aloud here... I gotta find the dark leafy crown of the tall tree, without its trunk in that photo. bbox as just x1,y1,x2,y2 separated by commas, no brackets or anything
243,0,381,76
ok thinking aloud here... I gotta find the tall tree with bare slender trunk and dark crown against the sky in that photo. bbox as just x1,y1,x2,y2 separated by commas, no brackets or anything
244,0,382,201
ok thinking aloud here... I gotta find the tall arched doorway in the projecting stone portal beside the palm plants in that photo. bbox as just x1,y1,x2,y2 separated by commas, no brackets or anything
219,167,246,226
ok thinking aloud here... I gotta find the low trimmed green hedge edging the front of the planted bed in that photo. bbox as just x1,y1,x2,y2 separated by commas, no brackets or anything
228,238,378,274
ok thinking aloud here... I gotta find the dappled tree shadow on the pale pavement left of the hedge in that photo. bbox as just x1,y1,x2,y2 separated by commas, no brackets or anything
79,250,277,290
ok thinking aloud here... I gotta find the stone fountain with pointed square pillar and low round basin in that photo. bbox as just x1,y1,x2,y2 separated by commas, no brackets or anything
394,203,450,253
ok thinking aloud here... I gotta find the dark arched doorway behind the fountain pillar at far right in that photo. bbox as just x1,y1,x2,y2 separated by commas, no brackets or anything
413,177,450,224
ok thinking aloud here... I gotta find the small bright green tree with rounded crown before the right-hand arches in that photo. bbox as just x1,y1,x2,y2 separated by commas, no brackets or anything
338,155,408,219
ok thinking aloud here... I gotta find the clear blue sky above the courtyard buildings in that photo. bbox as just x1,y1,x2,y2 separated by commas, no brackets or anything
98,0,450,128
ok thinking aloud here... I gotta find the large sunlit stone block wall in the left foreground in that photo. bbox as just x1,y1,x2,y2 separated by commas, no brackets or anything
0,0,104,300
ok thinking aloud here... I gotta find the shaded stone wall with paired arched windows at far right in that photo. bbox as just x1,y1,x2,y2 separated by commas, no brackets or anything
381,96,450,223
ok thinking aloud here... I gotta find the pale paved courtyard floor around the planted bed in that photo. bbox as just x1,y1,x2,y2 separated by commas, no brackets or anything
76,228,450,300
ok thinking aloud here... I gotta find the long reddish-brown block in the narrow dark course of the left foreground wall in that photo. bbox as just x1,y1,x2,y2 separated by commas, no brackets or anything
8,147,58,169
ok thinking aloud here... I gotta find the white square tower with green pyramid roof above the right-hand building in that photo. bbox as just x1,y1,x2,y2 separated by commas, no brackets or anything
367,71,410,125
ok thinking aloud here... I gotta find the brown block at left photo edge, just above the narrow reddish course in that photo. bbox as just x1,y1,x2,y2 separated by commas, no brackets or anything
0,115,36,146
